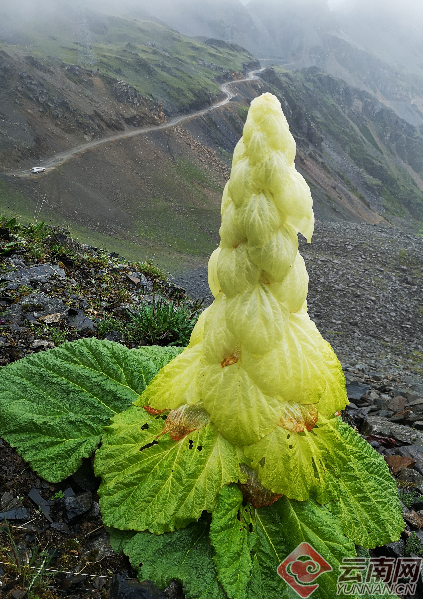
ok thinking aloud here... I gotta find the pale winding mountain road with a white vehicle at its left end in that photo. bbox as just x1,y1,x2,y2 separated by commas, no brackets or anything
0,69,264,178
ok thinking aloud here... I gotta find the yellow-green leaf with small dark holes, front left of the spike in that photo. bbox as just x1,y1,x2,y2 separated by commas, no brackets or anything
95,406,240,534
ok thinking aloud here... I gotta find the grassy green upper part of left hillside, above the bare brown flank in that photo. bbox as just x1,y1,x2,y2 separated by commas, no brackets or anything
0,3,254,115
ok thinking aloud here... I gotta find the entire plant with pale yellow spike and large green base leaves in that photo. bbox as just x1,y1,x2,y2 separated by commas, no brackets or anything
0,94,404,599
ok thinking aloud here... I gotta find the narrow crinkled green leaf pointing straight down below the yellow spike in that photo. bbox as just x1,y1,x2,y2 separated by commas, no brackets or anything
210,485,254,598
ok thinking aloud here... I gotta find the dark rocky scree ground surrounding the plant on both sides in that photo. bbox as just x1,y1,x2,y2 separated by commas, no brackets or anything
0,222,423,598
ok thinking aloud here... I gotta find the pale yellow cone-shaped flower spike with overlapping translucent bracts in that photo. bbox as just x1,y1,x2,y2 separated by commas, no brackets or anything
137,94,347,500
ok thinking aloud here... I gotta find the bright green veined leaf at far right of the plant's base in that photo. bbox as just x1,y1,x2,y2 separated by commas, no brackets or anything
327,422,405,548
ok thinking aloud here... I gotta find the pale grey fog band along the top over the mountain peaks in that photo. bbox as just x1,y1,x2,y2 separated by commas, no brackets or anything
0,0,423,54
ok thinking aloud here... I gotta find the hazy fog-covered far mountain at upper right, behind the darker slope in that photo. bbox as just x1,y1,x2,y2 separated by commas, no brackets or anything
121,0,423,125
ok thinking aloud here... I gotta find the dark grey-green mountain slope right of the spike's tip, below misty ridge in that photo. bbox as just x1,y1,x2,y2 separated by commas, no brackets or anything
262,67,423,221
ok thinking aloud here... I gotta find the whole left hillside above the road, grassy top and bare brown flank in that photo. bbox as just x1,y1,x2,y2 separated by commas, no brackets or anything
0,2,256,167
